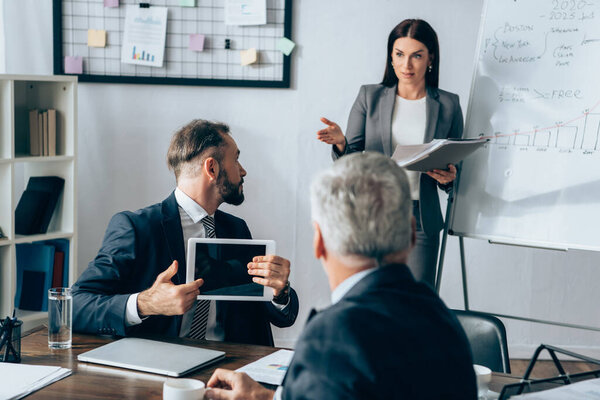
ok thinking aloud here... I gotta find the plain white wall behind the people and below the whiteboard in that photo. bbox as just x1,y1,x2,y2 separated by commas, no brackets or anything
5,0,600,357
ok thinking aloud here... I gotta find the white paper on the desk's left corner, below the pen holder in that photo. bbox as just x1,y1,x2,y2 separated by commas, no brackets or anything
0,363,71,400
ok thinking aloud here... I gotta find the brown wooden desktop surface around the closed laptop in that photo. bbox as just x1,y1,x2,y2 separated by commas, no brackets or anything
21,328,277,399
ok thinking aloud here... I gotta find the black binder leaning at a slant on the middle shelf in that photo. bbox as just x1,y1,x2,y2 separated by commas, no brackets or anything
15,176,65,235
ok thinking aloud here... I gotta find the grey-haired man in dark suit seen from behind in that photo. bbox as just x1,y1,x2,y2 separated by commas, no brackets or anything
206,153,477,400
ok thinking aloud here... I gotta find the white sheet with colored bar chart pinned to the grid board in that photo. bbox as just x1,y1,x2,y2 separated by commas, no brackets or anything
121,5,167,67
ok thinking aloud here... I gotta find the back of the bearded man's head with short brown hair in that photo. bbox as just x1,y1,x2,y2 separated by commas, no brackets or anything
167,119,229,179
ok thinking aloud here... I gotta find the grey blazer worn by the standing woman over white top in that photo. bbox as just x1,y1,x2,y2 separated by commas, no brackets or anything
332,84,463,236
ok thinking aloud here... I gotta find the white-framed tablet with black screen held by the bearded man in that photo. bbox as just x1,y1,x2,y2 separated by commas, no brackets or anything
186,238,275,301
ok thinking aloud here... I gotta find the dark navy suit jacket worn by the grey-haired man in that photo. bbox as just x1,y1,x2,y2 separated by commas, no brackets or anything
283,265,477,400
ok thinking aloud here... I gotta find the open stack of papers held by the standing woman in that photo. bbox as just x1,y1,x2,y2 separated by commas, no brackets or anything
392,139,488,172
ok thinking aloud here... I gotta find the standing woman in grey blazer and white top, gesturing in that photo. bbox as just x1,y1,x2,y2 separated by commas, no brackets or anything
317,19,463,287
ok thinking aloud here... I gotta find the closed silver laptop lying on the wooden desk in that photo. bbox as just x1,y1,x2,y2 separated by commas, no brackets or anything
77,338,225,377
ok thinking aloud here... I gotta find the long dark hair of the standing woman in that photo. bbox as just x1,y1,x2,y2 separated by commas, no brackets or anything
381,19,440,88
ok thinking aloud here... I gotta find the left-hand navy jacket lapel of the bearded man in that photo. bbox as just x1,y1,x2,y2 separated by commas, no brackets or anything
162,192,186,285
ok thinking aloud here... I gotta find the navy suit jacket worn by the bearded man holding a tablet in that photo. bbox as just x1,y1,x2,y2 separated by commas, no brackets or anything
73,193,298,346
